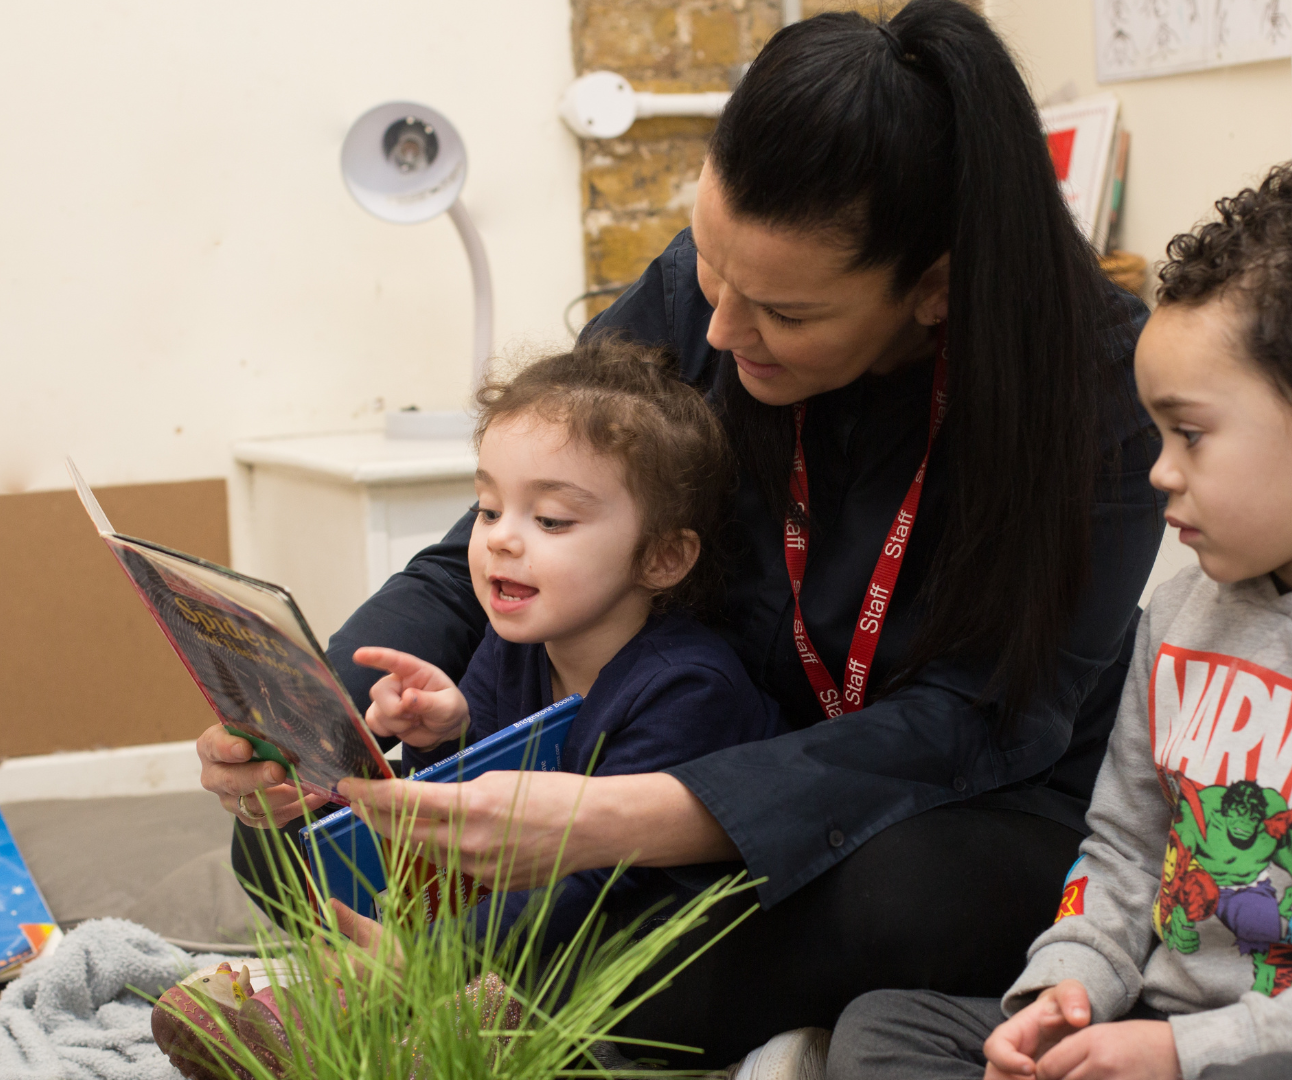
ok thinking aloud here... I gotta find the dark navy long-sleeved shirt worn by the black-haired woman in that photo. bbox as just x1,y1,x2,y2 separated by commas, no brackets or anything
329,230,1163,907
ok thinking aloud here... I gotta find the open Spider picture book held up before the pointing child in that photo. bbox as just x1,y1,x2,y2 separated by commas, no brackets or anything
67,459,394,802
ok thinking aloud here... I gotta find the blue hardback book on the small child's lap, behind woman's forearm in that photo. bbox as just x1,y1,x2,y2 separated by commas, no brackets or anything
301,694,583,919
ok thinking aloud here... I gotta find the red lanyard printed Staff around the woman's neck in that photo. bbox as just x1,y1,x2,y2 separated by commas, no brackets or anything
786,329,947,717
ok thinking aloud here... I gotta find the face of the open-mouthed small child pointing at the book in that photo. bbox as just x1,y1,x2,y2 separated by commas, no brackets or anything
468,416,650,643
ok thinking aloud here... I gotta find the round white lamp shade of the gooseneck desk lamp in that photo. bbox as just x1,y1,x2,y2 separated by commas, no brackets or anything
341,101,466,225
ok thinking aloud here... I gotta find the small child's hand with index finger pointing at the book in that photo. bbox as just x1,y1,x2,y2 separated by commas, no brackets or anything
354,647,470,748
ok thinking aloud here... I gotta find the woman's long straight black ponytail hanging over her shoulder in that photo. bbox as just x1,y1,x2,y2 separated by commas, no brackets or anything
891,0,1114,708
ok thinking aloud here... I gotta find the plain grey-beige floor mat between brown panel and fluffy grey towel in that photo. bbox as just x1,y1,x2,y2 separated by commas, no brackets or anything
0,792,265,951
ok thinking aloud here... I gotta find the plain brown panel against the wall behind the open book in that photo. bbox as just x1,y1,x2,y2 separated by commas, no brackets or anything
0,479,229,757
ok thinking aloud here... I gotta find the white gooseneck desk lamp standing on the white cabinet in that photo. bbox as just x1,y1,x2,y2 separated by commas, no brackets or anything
341,101,494,439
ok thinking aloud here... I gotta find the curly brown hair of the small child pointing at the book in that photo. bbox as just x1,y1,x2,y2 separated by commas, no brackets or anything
475,335,734,612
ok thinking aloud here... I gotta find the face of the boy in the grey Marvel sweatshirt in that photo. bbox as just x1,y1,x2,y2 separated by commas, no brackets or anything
1134,300,1292,585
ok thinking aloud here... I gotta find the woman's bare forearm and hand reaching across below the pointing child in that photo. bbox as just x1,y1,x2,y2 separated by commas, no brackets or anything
340,773,739,889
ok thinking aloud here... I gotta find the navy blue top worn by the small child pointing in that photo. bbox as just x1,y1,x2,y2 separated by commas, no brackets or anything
403,612,788,940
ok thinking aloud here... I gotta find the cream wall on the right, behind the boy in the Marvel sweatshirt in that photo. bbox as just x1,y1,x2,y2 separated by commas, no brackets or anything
986,0,1292,598
